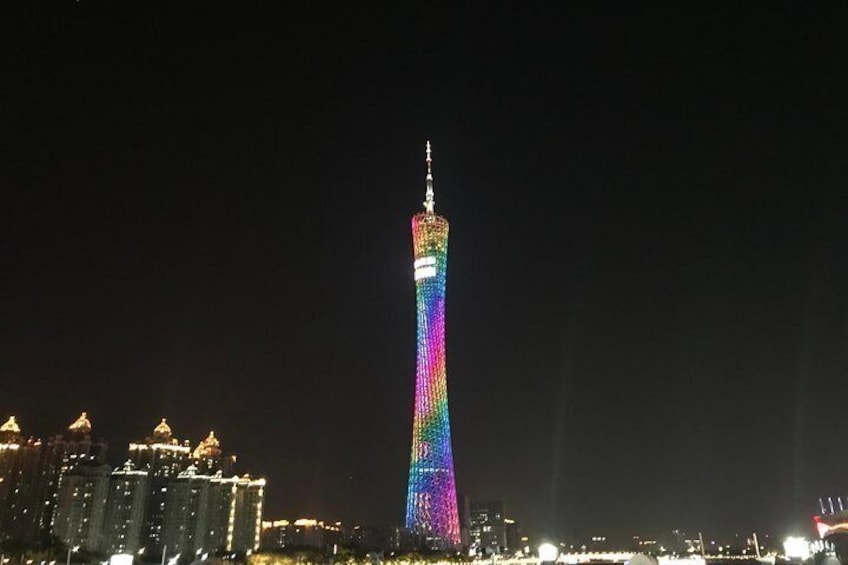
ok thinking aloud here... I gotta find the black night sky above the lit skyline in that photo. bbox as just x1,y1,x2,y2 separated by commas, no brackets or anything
0,0,848,536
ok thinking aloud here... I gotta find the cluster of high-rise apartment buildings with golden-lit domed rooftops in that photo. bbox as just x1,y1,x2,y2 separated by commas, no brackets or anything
0,412,266,561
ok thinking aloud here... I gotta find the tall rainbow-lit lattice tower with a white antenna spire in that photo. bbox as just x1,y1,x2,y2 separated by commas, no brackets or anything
406,141,459,546
